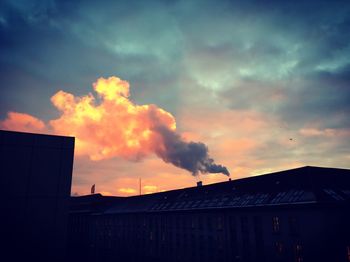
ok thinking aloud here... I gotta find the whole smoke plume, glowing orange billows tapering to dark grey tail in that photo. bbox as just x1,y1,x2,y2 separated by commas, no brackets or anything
0,77,229,175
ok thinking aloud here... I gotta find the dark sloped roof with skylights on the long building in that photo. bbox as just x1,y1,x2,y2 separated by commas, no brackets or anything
69,166,350,214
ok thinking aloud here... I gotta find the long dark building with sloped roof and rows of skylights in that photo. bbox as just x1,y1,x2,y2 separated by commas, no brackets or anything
69,167,350,262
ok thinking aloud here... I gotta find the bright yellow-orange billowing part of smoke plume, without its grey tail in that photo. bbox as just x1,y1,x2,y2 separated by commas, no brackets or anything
50,77,176,160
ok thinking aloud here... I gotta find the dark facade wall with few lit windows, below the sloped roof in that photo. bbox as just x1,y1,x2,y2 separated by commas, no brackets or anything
82,205,348,262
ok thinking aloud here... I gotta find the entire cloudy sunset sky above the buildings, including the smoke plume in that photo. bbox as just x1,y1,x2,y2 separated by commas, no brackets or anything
0,0,350,196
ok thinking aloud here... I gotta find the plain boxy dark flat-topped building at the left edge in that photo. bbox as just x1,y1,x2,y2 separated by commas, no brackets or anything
0,130,74,261
